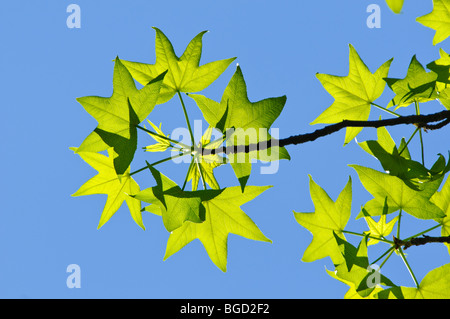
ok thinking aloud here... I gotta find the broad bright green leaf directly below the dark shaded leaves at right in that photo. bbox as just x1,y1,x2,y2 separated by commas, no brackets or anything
350,165,445,219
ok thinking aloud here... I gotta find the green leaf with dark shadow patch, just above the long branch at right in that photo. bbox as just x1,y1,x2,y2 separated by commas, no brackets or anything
385,55,438,109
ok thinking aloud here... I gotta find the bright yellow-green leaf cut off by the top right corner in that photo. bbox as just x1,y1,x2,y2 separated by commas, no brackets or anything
416,0,450,45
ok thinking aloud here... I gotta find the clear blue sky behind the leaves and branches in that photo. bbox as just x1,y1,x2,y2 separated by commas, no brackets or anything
0,0,450,298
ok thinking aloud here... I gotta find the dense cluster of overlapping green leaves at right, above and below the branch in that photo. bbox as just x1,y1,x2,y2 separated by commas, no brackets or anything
294,42,450,298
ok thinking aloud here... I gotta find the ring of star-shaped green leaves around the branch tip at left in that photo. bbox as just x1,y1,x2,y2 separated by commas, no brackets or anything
72,28,289,271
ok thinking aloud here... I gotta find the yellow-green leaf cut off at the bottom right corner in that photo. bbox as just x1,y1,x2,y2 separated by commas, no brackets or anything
378,264,450,299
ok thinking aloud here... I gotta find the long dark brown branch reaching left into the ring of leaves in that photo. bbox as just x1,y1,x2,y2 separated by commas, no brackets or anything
202,111,450,155
